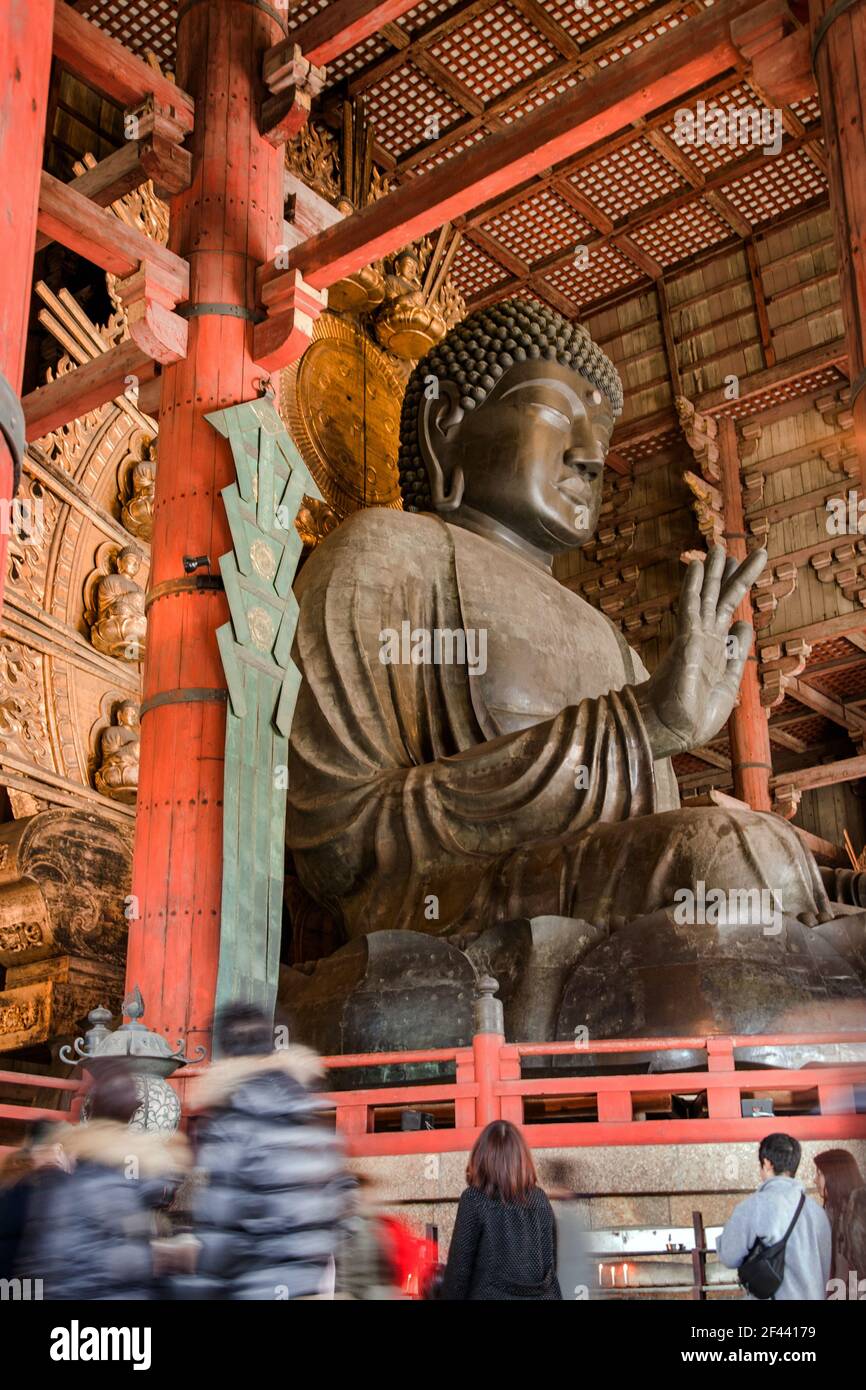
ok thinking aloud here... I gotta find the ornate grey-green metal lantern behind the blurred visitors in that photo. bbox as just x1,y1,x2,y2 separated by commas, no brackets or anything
60,986,207,1133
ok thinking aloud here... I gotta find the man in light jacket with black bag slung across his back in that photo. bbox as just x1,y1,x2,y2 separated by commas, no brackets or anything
716,1134,833,1302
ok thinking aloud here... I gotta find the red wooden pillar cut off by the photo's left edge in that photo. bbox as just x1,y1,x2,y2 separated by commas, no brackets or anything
0,0,54,603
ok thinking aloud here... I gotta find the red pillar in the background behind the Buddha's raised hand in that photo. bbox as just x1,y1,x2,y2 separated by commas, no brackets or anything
719,417,773,810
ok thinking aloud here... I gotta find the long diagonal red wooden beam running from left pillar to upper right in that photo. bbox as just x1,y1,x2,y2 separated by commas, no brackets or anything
268,0,751,291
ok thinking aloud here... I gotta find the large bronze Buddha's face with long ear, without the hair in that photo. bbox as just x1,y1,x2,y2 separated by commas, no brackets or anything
420,359,613,555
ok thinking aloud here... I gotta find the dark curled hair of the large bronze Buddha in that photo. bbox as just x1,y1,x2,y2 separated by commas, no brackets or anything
398,299,623,512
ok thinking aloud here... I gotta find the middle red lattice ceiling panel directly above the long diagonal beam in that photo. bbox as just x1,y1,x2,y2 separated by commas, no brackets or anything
428,4,562,101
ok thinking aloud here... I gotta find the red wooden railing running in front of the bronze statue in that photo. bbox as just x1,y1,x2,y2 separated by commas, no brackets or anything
0,1033,866,1156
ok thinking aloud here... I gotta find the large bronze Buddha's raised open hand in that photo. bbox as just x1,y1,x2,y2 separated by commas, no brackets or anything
635,546,767,758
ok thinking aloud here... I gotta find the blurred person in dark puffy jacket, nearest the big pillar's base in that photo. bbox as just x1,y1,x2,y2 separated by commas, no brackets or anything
183,1005,354,1298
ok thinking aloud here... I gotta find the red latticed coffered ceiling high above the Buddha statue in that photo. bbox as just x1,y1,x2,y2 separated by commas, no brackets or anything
67,0,827,317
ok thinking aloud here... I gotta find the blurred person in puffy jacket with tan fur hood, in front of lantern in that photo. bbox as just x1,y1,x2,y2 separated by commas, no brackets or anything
17,1061,190,1301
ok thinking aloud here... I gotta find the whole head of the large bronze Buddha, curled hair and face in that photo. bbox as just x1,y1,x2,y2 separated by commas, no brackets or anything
399,299,623,555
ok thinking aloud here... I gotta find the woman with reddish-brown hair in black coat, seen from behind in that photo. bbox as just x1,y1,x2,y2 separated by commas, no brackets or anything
441,1120,562,1302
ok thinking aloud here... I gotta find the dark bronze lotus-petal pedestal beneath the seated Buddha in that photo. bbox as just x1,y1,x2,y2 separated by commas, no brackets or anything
279,909,866,1070
